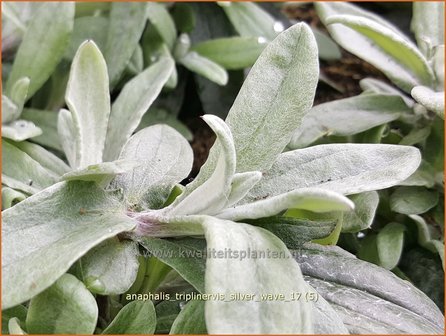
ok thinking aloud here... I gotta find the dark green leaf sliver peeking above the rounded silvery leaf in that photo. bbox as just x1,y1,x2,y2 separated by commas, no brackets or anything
136,107,194,141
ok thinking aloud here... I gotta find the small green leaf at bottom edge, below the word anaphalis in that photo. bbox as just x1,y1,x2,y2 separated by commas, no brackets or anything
102,300,156,335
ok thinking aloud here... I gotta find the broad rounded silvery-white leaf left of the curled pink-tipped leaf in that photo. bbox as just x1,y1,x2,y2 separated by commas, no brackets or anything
113,125,193,209
